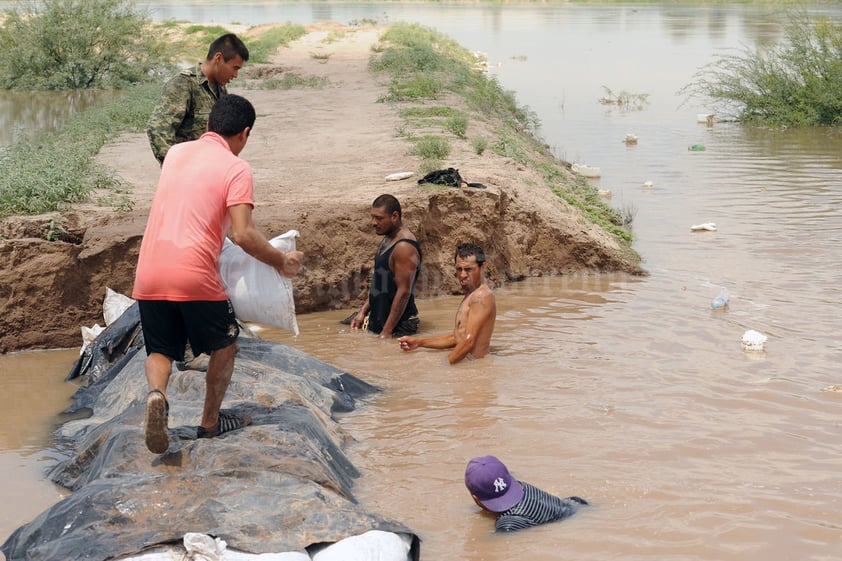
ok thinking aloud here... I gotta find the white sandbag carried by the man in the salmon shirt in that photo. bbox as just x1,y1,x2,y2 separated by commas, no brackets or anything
219,230,298,335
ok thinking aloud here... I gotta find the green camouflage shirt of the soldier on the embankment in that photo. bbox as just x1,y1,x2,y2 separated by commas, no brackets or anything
146,63,228,163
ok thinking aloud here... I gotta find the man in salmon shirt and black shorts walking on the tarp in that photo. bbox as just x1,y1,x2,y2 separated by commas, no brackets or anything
132,95,304,454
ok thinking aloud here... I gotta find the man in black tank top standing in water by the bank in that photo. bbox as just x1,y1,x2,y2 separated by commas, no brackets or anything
351,195,421,339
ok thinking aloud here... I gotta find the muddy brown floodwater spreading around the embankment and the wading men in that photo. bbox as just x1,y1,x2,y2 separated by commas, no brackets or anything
0,3,842,561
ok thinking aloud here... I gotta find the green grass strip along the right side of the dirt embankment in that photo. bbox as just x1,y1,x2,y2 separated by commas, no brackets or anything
369,23,631,243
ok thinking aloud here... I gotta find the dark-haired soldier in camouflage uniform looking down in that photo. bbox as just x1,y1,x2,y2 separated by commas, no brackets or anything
146,33,249,164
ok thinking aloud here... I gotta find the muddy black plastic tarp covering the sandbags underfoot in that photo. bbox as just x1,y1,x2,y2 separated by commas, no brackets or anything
0,338,419,561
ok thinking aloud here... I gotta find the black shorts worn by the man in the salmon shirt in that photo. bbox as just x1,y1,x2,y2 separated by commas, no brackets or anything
138,300,240,361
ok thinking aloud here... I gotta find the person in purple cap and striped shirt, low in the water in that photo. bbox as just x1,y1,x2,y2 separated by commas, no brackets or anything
465,456,588,532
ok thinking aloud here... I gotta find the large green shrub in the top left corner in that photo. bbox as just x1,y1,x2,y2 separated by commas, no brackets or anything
0,0,164,90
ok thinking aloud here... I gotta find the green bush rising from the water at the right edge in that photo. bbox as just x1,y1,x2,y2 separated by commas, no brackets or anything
681,13,842,126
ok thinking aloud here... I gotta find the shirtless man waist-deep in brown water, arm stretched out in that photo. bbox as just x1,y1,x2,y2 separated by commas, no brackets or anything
398,243,497,364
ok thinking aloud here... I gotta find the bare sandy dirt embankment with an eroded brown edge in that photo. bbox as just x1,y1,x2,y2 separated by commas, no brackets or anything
0,24,640,352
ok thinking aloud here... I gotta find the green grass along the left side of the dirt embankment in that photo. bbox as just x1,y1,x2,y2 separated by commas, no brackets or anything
0,11,312,218
